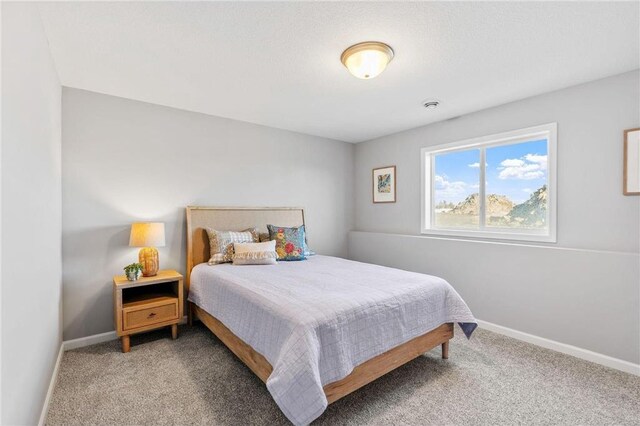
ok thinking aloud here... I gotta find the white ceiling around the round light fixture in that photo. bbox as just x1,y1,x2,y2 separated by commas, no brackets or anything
40,2,640,142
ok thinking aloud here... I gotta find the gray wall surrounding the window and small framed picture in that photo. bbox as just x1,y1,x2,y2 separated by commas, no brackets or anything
349,71,640,363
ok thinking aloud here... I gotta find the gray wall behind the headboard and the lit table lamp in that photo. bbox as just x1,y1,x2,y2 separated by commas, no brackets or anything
62,88,354,340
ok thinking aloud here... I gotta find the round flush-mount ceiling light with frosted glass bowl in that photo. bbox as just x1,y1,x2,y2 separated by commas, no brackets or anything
340,41,393,80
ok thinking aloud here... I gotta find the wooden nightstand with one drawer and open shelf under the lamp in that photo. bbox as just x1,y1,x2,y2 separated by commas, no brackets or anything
113,270,184,352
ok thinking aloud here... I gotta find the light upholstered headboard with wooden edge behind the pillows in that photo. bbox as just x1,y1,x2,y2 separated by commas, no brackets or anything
187,206,304,290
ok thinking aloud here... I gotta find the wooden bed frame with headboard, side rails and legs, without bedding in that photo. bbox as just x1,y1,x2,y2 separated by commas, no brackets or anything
186,206,453,404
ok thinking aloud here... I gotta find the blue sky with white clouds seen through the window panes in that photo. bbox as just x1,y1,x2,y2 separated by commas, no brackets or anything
435,139,547,203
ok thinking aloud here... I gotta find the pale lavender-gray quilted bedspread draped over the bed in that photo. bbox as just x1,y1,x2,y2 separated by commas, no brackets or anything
189,256,476,425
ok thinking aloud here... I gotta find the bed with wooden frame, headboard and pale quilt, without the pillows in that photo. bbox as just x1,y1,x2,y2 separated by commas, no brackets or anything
186,206,476,424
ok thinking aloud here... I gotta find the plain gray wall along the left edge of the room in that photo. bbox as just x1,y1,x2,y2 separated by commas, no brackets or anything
0,3,62,425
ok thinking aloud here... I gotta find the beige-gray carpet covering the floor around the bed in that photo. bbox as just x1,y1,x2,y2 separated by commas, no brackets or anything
47,325,640,425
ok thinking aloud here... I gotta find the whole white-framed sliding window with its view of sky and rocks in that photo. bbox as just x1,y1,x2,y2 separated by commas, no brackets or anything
422,123,556,242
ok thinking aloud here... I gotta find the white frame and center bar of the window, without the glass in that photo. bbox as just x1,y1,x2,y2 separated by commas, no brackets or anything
420,123,558,243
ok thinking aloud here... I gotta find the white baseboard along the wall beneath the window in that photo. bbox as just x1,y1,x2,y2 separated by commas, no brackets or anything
478,320,640,376
